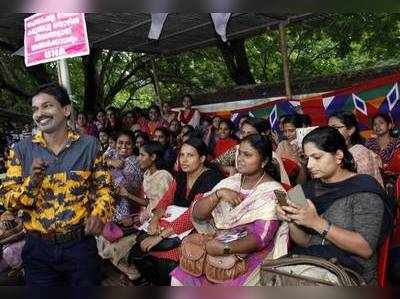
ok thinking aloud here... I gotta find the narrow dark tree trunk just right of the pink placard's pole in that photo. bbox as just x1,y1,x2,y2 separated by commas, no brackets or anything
82,49,100,113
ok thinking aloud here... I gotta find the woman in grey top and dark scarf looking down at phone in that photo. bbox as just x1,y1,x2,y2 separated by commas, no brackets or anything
277,127,391,283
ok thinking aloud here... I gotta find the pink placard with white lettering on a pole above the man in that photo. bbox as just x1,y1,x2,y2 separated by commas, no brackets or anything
25,13,90,66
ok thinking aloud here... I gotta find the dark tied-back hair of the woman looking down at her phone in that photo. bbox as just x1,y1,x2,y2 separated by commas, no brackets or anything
303,127,357,172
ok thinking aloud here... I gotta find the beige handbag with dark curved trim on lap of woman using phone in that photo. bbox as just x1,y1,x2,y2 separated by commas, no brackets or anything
260,255,366,287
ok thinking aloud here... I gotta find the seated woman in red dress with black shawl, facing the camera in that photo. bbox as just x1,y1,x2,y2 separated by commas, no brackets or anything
131,138,222,286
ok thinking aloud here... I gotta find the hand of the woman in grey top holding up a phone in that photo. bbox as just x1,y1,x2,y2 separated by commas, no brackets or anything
282,199,326,232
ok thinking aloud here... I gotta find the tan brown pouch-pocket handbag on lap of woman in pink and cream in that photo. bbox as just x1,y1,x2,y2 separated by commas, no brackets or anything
179,234,247,283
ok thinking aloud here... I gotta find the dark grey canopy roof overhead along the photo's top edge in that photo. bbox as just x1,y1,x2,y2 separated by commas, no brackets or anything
0,13,332,55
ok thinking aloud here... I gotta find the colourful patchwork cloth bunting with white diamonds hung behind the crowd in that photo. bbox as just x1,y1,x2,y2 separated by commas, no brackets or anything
199,72,400,130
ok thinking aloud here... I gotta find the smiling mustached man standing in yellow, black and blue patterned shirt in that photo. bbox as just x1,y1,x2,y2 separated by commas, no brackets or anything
1,84,113,286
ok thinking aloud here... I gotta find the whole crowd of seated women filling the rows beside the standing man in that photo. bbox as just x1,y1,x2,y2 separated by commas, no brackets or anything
1,95,400,286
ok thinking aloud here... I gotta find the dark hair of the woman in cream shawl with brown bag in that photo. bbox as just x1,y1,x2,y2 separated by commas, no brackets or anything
242,134,281,182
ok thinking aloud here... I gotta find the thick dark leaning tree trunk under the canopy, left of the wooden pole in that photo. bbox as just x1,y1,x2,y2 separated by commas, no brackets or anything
218,39,255,85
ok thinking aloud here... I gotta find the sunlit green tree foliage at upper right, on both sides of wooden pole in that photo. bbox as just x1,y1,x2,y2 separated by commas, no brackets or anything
247,14,400,82
